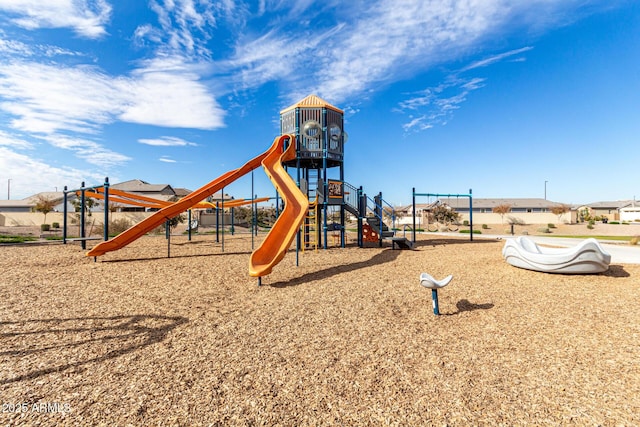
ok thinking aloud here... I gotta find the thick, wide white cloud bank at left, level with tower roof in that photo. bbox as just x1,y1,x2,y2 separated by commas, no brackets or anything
0,58,224,134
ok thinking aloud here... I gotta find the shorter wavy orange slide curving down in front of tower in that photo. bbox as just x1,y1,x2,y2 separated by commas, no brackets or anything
249,136,309,277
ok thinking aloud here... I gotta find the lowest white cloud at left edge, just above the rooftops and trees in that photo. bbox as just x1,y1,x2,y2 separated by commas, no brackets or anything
0,146,104,200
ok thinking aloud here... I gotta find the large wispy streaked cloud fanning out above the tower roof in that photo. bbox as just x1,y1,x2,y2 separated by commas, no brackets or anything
230,0,606,109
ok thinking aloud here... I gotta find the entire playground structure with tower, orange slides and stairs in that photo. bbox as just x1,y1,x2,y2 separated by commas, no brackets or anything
65,95,415,278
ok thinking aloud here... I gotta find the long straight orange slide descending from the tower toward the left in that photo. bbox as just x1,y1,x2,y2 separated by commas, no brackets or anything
87,135,286,257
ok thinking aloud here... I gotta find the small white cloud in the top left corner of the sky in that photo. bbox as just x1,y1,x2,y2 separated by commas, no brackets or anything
0,0,111,39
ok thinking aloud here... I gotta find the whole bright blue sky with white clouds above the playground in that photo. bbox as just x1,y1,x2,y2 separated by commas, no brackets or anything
0,0,640,204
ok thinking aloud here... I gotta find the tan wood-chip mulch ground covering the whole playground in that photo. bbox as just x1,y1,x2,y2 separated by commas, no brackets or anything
0,235,640,426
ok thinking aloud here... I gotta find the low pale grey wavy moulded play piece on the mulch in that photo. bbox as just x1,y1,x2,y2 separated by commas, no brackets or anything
502,236,611,274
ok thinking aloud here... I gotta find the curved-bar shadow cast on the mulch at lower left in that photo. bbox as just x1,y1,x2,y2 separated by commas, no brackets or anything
0,315,189,384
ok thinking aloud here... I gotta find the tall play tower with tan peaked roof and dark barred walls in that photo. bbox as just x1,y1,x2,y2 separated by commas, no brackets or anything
280,95,347,248
